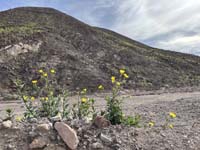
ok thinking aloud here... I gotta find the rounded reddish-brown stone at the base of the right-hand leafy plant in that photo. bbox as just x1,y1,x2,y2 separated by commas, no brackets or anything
93,116,111,128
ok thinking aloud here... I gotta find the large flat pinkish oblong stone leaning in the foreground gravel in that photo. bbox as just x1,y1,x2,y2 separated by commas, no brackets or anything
55,122,79,149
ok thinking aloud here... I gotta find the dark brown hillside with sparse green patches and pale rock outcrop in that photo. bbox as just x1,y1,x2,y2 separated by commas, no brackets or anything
0,7,200,90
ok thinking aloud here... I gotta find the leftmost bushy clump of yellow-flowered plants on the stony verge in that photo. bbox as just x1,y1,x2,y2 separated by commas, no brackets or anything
14,69,69,118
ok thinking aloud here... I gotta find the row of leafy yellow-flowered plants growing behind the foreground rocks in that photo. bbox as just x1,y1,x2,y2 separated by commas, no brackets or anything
14,69,140,126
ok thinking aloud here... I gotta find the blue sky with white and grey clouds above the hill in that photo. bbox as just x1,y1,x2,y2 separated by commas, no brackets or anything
0,0,200,55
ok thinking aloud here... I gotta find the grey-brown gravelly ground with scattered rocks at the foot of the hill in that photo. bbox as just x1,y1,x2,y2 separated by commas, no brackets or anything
0,89,200,150
